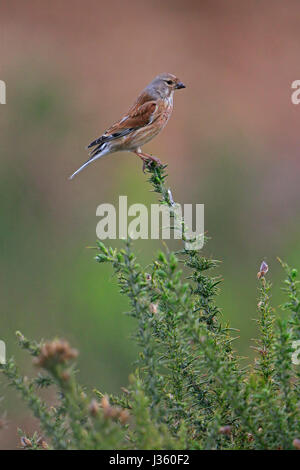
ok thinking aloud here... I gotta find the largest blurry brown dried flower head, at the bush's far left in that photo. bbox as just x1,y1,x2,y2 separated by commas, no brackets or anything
34,340,78,369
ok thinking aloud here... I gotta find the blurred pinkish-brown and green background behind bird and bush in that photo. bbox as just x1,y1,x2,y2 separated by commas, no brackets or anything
0,0,300,449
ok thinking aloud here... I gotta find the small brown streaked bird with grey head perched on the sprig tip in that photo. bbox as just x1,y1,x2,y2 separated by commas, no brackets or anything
70,73,185,179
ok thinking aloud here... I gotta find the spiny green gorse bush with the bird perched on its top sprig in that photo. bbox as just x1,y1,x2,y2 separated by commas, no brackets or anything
1,164,300,449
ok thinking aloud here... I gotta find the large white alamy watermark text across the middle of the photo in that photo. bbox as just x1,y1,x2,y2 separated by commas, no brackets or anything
96,196,204,250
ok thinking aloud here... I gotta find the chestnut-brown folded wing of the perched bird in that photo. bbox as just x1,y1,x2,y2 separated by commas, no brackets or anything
88,95,157,153
